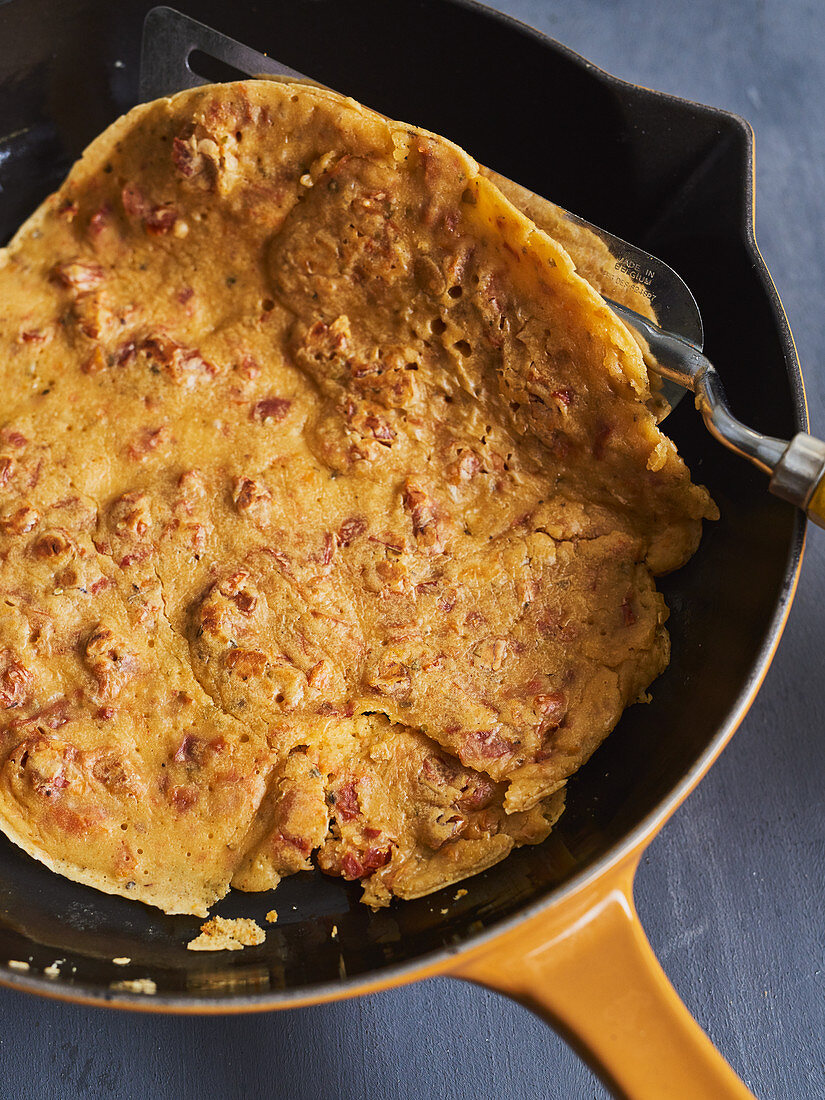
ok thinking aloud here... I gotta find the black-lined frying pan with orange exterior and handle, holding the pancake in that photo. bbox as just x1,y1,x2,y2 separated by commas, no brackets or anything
0,0,807,1098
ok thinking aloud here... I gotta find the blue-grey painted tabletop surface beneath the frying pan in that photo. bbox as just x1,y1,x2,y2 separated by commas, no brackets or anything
0,0,825,1100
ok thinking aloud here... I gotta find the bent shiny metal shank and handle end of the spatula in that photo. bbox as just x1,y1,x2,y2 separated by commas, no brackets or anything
607,299,825,527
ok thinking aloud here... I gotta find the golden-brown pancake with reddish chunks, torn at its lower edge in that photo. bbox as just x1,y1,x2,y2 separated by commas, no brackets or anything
0,81,715,915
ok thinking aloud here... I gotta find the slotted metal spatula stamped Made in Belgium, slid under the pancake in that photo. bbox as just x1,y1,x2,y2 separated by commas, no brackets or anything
140,7,825,527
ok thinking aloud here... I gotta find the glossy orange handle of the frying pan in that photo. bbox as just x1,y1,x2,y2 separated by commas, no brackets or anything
453,855,754,1100
